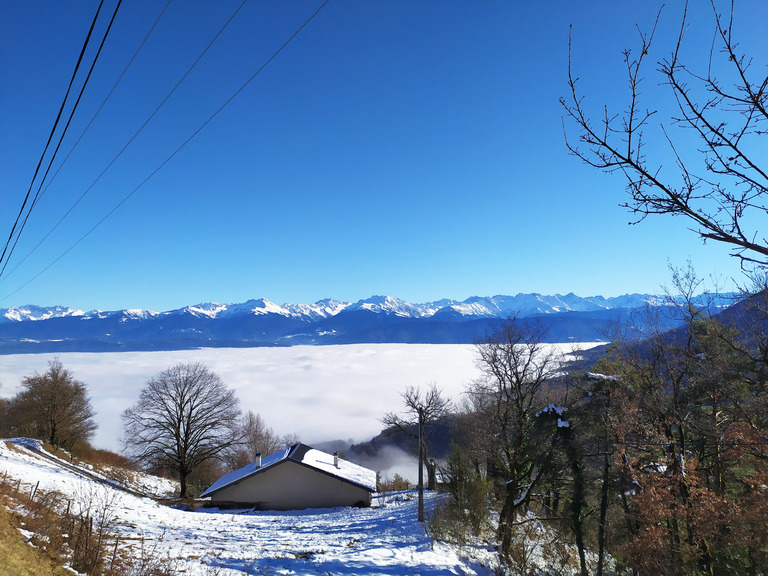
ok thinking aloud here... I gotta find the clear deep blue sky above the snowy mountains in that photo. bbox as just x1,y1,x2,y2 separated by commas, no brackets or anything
0,0,768,310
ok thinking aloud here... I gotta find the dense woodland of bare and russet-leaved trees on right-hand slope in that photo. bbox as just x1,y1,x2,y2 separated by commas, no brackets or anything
408,268,768,576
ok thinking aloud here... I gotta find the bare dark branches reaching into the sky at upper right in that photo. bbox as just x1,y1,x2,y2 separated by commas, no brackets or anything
560,0,768,265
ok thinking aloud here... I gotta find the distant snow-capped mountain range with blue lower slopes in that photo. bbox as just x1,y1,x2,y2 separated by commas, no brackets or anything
0,293,732,354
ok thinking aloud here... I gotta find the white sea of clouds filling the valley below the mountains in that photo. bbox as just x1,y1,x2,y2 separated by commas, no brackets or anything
0,343,596,450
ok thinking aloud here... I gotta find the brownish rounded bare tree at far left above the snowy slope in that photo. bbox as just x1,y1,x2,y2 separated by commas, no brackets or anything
7,358,96,450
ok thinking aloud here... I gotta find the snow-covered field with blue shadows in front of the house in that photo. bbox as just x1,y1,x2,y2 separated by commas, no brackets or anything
0,441,495,576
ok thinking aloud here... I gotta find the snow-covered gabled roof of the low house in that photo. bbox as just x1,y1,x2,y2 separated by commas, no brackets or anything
200,443,376,498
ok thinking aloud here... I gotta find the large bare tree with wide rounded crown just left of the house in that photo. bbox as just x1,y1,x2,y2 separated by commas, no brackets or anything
122,363,243,498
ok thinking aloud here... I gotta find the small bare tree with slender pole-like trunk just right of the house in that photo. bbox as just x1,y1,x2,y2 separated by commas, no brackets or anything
382,382,451,522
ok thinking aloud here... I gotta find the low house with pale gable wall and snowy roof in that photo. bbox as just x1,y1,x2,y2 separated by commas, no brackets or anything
200,443,376,510
